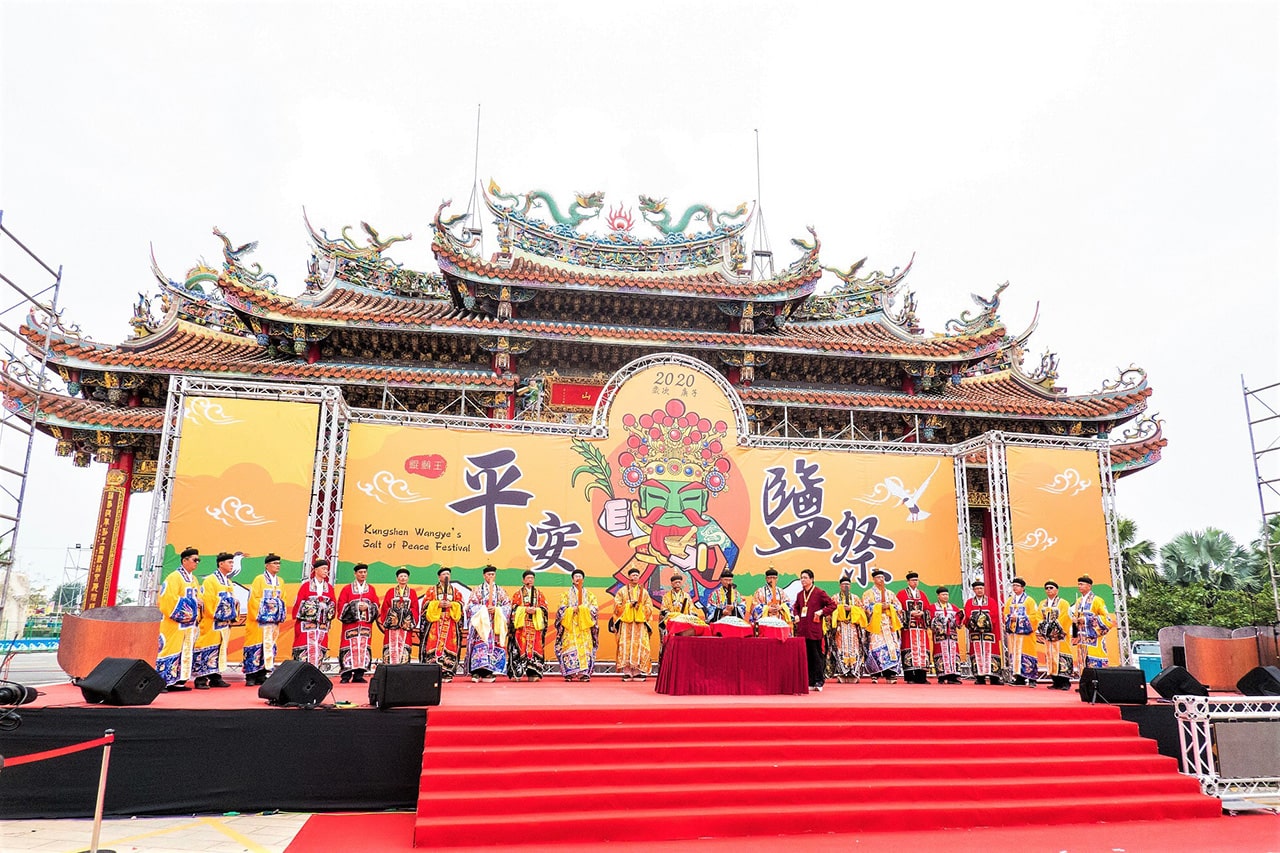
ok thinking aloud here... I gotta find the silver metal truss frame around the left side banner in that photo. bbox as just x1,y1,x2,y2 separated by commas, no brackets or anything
141,377,351,605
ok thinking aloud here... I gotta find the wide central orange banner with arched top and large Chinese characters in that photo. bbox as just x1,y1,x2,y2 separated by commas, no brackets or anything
339,364,960,604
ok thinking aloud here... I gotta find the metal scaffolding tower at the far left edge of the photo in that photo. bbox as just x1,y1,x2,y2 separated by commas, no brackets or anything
0,210,63,637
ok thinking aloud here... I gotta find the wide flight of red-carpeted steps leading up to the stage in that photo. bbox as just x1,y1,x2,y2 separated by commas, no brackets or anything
413,699,1221,847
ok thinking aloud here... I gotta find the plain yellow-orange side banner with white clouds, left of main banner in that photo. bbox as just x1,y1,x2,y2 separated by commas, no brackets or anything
164,397,320,571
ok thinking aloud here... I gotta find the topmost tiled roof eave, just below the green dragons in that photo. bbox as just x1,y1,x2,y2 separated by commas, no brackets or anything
431,240,822,302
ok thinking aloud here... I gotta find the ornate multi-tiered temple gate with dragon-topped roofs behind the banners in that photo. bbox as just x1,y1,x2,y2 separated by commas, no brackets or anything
0,183,1166,606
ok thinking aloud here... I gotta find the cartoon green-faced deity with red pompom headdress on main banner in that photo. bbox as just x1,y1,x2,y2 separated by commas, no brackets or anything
573,400,739,602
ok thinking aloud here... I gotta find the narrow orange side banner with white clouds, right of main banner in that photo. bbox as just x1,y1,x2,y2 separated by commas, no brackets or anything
1005,446,1119,663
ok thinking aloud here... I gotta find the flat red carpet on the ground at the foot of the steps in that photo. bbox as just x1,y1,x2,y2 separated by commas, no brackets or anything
285,812,1280,853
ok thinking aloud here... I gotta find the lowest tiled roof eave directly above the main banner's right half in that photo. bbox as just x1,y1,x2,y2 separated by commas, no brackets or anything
740,375,1151,424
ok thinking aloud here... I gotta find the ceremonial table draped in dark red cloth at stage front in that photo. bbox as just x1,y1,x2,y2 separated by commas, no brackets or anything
657,637,809,695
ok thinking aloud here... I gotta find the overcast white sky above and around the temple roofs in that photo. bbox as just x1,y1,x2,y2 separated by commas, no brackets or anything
0,0,1280,591
